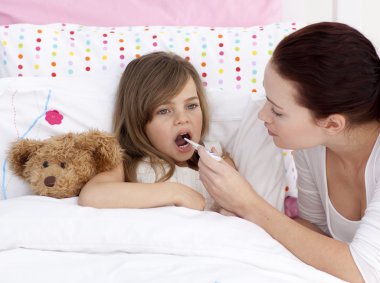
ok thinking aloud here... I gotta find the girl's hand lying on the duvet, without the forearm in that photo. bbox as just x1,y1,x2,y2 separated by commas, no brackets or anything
168,183,206,210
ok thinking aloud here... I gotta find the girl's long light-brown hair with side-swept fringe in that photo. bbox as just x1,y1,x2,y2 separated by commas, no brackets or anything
113,52,209,182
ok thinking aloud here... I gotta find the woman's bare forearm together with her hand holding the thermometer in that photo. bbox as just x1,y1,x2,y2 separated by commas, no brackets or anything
198,148,363,282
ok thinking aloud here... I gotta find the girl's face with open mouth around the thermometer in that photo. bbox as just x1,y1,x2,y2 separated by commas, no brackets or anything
145,78,202,164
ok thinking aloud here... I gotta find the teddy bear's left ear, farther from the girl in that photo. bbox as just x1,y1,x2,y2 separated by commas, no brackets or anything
8,139,43,177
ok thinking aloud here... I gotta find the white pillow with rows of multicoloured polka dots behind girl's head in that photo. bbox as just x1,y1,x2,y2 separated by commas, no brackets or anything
0,23,300,95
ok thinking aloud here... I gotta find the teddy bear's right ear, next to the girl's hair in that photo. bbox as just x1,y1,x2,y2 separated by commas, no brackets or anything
75,130,123,173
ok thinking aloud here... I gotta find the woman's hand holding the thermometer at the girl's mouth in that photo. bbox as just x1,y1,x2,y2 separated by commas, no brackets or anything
198,147,257,216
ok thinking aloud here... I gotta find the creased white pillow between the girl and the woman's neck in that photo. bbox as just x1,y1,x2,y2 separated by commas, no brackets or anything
230,100,288,211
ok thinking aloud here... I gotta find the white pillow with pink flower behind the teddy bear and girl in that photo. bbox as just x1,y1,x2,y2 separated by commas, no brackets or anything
0,75,255,199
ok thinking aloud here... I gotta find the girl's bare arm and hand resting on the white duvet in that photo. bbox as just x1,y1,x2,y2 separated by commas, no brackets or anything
79,164,205,210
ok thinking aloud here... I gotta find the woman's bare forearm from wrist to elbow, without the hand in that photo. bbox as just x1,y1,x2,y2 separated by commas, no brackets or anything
240,196,364,282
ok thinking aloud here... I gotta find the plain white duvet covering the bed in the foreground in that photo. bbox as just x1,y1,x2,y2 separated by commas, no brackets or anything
0,196,342,283
